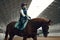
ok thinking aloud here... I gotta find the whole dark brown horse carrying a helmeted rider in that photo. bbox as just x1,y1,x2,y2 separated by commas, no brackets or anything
4,18,51,40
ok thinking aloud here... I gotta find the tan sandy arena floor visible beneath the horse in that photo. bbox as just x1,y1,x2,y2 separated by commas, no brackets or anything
13,36,60,40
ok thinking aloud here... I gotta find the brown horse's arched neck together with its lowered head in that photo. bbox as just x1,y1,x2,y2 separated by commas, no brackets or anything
33,18,51,37
